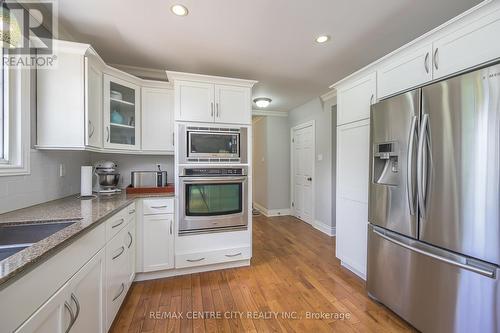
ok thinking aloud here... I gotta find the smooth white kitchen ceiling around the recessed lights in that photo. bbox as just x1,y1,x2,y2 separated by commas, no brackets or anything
59,0,481,111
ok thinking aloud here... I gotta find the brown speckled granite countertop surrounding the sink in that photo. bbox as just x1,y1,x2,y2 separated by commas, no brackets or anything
0,193,174,289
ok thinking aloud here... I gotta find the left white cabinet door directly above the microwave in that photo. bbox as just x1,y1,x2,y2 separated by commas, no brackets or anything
174,81,215,122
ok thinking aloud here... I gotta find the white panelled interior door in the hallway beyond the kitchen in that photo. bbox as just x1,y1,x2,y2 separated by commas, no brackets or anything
292,124,314,224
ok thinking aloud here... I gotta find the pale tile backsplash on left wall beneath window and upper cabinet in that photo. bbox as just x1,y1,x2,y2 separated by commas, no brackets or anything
0,150,90,213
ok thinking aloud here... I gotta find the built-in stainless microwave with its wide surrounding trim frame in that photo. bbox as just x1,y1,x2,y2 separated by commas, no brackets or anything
179,125,247,163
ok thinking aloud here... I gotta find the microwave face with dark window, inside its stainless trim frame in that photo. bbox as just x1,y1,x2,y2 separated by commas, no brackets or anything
187,131,240,158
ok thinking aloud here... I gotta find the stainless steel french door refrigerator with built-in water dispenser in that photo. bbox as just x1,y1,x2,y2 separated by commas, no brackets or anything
367,65,500,332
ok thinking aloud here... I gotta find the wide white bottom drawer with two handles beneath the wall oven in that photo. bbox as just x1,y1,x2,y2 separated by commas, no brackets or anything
175,246,251,268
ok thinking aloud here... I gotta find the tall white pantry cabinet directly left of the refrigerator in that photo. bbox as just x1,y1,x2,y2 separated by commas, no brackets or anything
336,73,377,278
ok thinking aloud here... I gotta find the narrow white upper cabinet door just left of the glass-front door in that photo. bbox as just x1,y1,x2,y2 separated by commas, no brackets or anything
85,56,103,148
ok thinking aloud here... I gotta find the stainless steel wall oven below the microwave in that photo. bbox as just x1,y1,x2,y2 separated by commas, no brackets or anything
179,166,248,235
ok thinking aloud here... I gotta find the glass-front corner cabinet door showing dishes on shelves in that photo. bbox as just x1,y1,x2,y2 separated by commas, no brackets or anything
104,75,141,149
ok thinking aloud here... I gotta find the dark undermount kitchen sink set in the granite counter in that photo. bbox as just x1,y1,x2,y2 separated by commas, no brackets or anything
0,221,76,261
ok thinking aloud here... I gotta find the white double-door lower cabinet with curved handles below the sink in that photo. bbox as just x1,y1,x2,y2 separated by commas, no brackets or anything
16,250,105,333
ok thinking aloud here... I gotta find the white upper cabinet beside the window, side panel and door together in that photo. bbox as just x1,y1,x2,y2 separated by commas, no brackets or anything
36,41,102,149
